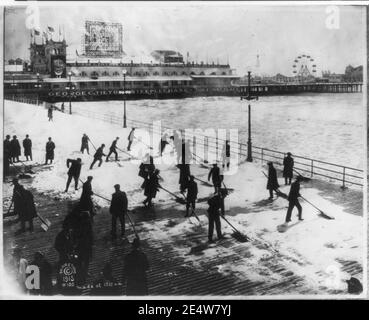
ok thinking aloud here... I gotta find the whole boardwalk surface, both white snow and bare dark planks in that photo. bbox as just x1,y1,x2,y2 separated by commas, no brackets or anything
3,102,366,296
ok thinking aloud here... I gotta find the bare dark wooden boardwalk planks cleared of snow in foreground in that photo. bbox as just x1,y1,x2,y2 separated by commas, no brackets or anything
4,169,363,296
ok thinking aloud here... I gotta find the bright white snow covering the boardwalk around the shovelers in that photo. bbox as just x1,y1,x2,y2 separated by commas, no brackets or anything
4,101,364,294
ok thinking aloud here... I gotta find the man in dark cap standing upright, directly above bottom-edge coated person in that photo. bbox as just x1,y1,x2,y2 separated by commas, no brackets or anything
109,184,128,240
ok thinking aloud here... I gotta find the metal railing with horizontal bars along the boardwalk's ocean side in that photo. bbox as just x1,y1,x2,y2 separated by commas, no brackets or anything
67,110,364,188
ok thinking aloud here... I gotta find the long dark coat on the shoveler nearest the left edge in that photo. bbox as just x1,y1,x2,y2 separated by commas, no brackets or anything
13,185,37,221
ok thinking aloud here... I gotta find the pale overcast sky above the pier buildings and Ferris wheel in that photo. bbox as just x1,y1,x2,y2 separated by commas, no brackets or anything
5,2,365,75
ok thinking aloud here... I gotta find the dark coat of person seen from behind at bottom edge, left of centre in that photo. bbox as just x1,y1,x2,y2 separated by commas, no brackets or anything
124,249,149,296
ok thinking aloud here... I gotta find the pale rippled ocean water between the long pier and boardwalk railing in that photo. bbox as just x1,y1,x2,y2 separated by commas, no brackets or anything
73,93,366,169
